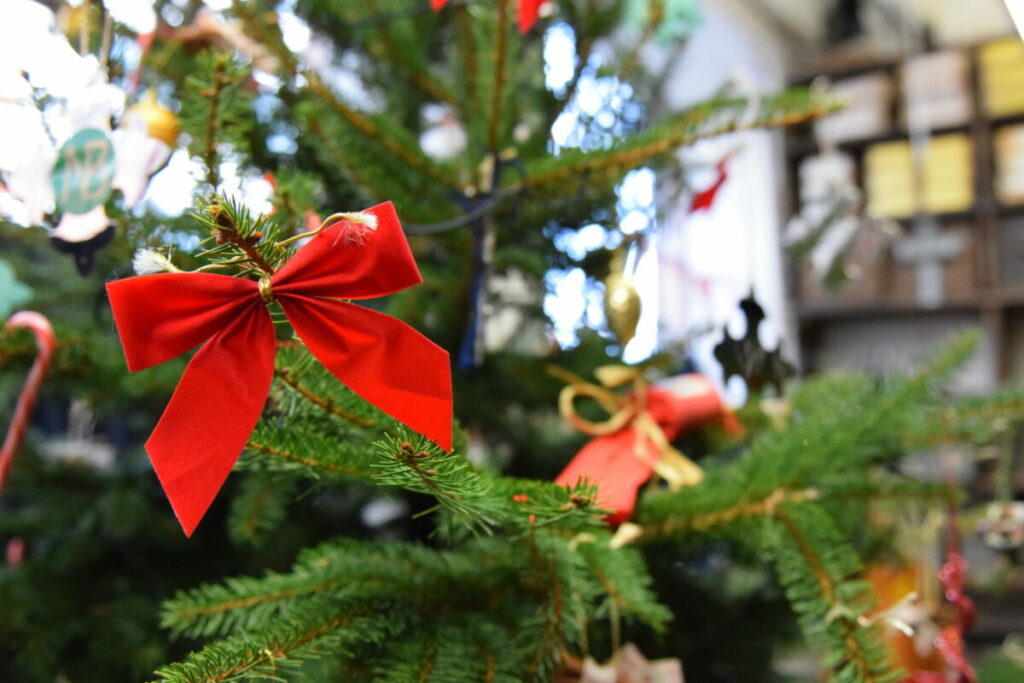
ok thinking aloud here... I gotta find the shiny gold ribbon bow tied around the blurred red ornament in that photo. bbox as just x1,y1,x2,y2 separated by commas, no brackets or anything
549,366,703,490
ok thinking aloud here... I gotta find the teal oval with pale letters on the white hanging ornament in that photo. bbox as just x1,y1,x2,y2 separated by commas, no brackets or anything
53,128,114,214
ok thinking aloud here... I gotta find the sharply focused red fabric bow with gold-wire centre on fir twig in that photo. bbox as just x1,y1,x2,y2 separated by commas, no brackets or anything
106,203,452,536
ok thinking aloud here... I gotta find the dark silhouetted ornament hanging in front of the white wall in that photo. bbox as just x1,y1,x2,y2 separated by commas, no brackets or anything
715,293,794,396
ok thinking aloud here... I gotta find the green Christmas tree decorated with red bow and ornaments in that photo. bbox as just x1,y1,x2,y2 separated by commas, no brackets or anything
0,0,1021,682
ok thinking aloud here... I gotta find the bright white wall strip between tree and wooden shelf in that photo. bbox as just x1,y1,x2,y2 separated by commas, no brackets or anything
658,0,797,399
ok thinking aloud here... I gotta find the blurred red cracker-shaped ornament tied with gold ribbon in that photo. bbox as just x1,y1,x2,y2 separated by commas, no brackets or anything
555,374,742,524
